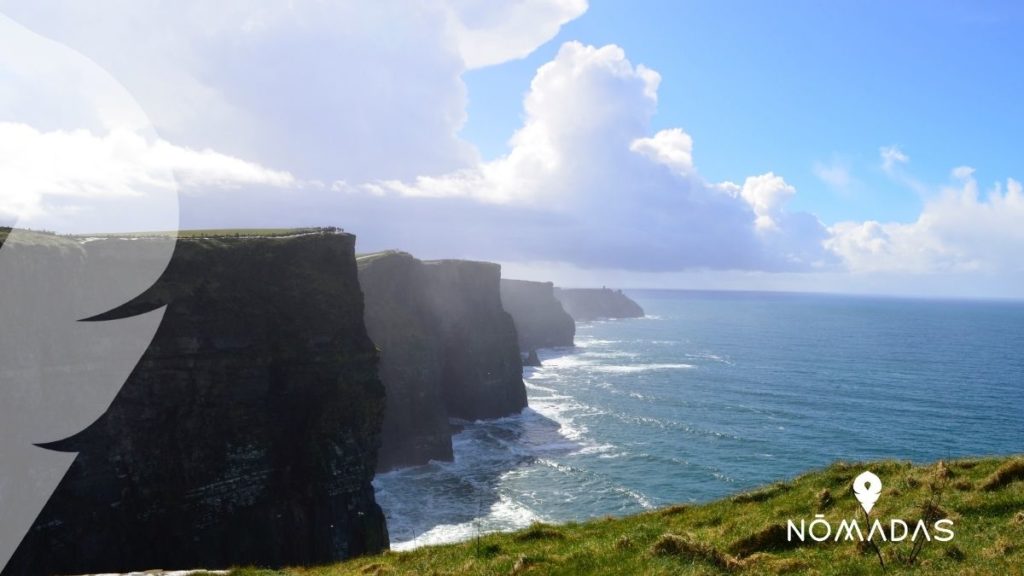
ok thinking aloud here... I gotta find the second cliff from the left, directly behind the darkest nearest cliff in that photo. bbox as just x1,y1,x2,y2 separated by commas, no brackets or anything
357,252,452,470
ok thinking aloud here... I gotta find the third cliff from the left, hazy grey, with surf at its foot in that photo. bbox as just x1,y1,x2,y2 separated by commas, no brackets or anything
424,260,526,420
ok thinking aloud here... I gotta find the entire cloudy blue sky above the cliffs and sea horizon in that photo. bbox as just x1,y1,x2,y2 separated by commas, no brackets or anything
0,0,1024,298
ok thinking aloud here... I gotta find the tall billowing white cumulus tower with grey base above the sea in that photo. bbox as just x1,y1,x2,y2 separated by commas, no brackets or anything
319,42,829,271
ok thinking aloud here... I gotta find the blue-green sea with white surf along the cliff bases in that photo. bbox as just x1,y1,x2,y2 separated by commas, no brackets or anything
375,291,1024,548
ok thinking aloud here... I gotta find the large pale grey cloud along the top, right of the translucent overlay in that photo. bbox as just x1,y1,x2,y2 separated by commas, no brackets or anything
0,0,587,181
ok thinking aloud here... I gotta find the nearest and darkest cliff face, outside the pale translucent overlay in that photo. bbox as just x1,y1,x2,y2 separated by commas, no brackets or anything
4,233,388,574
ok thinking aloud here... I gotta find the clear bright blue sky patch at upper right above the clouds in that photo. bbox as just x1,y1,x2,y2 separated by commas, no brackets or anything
462,0,1024,223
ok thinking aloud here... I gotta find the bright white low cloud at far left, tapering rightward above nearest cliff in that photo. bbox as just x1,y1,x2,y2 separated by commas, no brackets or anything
0,122,295,232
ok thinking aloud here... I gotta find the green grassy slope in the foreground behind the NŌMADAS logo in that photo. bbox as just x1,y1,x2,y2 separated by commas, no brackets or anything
231,456,1024,576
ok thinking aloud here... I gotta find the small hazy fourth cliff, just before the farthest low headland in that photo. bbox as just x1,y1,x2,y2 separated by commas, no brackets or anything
502,278,575,352
